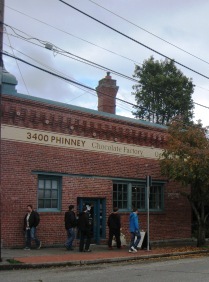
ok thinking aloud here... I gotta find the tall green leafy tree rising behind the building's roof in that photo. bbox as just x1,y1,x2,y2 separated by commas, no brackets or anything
132,57,194,124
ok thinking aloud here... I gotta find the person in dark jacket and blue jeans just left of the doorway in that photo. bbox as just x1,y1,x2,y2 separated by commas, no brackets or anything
65,205,77,251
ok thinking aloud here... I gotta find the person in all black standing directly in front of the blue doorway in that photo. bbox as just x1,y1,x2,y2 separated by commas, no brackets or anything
78,206,91,252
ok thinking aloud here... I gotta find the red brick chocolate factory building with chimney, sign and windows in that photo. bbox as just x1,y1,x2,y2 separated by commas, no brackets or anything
1,70,191,247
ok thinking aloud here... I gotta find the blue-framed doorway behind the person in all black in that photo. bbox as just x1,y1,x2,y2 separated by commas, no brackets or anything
77,198,106,244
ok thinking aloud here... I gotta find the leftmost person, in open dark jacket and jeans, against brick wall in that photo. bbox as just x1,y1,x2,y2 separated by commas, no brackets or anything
24,205,41,250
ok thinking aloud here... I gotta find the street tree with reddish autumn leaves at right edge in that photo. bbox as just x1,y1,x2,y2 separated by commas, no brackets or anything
160,121,209,246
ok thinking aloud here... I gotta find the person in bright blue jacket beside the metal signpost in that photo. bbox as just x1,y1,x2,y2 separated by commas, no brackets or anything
129,208,141,253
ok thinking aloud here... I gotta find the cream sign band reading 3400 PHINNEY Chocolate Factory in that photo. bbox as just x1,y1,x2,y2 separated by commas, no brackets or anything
1,125,163,159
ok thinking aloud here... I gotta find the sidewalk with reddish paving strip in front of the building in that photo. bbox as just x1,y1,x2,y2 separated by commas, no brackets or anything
0,245,209,270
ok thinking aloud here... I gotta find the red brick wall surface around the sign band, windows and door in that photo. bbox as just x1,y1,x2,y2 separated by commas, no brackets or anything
1,96,191,247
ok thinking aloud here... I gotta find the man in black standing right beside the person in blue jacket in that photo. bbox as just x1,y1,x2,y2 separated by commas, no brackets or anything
107,207,121,250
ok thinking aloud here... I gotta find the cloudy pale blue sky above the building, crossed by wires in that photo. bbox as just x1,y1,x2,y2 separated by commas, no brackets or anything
3,0,209,126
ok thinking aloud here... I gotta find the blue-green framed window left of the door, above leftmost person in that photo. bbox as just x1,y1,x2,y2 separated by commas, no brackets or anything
38,175,61,211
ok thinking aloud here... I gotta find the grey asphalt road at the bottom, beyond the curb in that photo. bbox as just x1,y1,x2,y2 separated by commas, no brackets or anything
0,257,209,282
